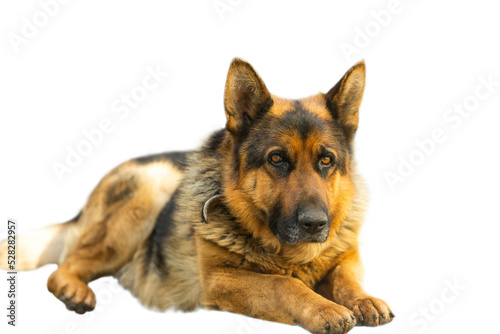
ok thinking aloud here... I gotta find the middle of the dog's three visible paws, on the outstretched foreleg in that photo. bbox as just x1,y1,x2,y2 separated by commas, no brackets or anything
301,303,356,334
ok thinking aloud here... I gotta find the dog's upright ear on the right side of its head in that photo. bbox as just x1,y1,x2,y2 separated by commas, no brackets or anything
325,61,366,140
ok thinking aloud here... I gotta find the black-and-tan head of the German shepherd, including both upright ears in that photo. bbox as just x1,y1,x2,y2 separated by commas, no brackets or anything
223,59,365,245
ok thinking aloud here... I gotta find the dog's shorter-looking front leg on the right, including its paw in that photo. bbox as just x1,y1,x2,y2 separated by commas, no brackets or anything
316,248,394,326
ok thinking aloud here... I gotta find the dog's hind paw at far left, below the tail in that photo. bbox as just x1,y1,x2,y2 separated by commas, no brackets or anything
47,270,96,314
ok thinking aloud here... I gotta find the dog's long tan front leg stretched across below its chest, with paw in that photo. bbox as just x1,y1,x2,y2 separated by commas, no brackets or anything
199,243,356,333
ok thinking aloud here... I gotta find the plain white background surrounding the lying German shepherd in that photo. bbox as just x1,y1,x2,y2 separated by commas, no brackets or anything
0,0,500,334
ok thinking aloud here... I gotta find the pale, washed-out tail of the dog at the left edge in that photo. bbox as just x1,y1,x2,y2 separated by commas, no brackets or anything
0,218,77,271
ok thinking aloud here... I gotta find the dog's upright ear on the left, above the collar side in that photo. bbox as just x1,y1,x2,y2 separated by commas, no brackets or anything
224,58,272,135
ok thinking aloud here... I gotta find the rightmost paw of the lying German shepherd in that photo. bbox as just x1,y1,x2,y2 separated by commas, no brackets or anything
349,296,395,327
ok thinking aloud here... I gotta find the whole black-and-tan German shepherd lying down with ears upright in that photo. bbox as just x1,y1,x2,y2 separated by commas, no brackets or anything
0,59,394,333
